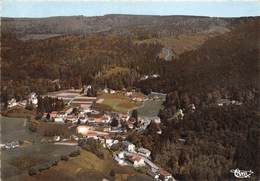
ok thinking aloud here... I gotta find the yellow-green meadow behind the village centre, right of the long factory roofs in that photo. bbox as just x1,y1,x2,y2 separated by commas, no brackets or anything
96,94,141,113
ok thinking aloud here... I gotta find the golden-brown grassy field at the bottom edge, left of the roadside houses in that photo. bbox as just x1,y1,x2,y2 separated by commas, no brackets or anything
18,150,117,181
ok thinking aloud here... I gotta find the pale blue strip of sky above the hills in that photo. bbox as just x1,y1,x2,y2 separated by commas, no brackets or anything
0,0,260,17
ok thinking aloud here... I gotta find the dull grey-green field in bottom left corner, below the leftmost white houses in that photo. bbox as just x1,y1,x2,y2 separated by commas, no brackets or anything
1,144,78,180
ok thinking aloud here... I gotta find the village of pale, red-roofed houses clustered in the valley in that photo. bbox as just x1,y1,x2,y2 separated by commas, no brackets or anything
3,85,177,181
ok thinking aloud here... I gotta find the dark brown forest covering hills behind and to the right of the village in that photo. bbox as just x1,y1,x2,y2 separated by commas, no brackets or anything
1,15,260,180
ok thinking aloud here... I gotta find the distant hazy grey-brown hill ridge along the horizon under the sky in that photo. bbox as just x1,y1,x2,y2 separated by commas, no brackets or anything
1,14,259,35
